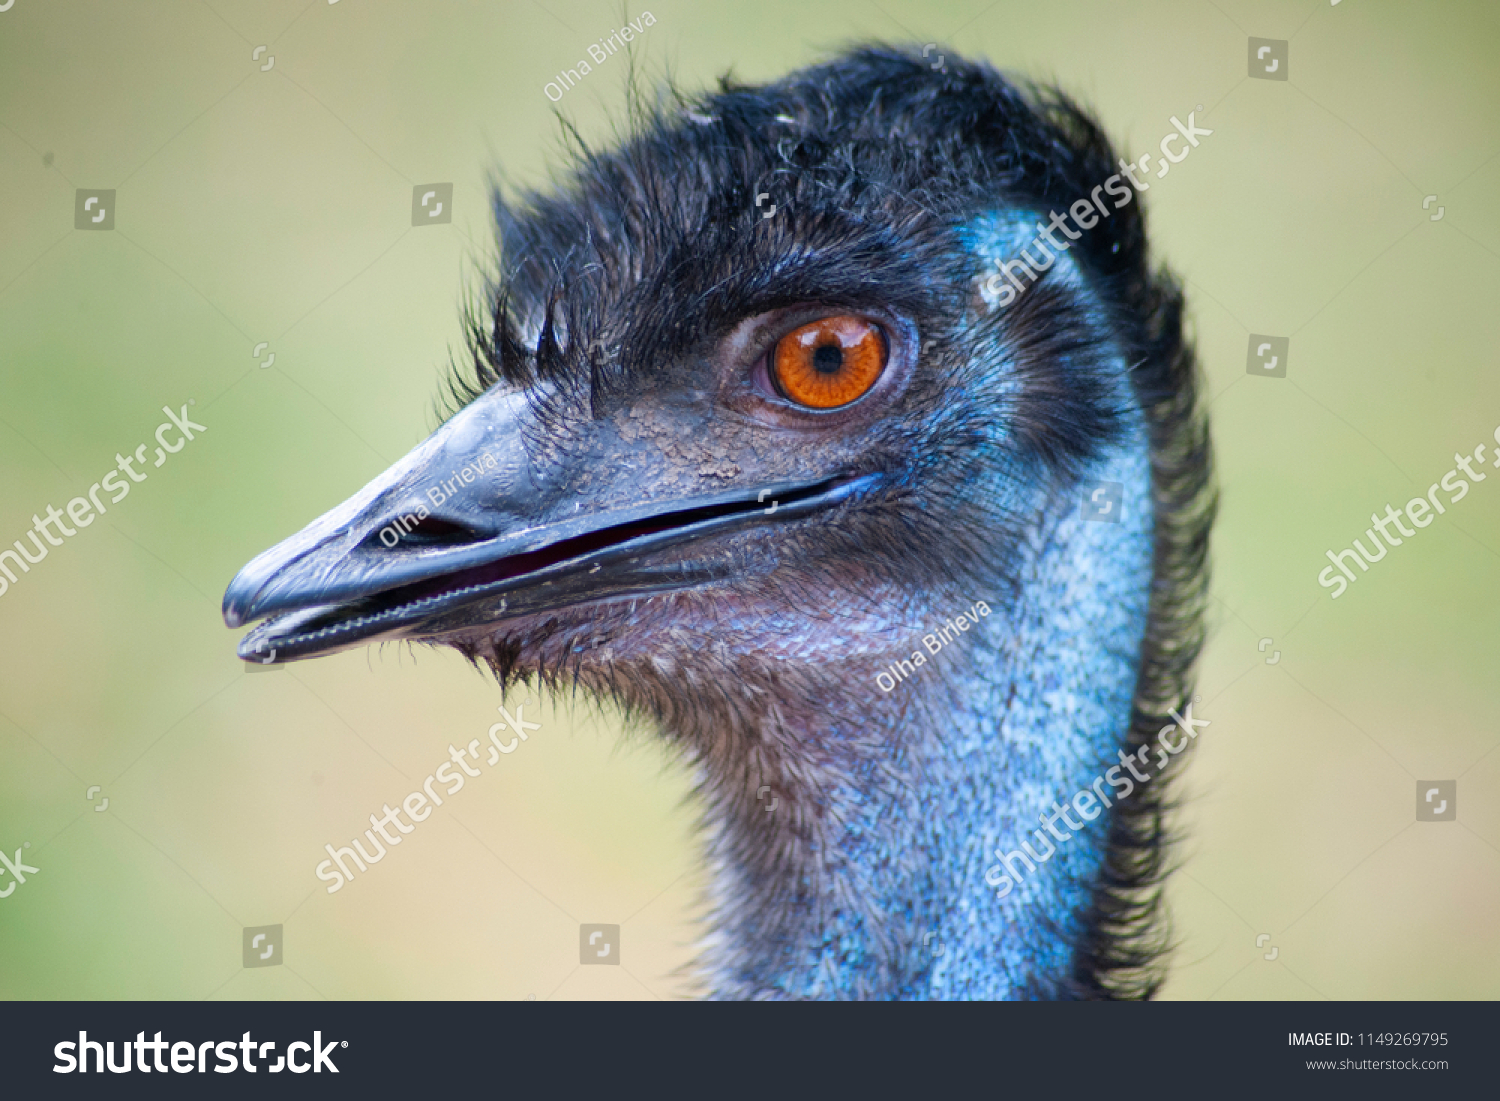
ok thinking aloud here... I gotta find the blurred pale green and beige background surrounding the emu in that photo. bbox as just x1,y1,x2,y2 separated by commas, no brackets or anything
0,0,1500,999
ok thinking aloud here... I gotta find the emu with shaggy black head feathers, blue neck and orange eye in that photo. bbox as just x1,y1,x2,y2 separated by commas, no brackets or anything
224,45,1214,999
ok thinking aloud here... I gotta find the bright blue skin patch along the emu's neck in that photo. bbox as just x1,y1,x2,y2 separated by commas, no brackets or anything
710,449,1151,999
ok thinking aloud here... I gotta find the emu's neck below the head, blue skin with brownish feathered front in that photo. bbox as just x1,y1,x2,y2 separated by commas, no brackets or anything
699,441,1152,999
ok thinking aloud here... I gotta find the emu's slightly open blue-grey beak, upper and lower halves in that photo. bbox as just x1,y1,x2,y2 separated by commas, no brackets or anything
224,395,875,665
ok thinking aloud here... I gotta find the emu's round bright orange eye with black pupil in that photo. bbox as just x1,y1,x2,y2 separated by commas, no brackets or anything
770,314,891,410
